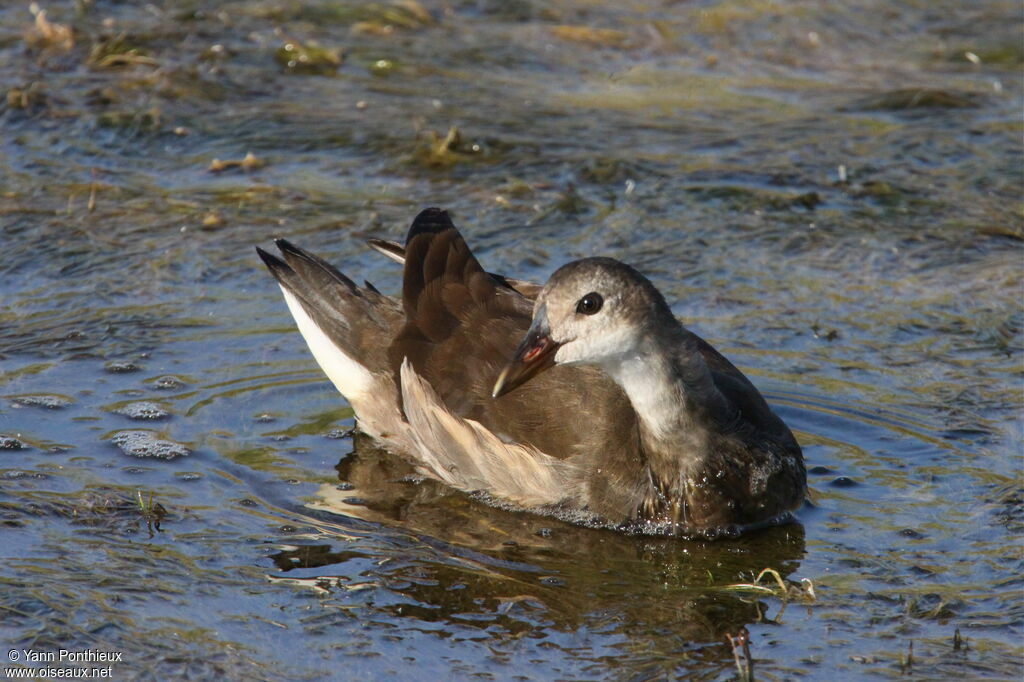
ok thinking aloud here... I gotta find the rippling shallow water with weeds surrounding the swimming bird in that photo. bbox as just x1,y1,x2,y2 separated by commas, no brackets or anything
0,0,1024,680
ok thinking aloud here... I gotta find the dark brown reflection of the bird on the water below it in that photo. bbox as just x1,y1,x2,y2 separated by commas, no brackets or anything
282,435,805,663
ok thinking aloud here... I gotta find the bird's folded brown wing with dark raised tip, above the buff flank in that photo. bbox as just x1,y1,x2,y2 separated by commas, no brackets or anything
388,209,644,520
